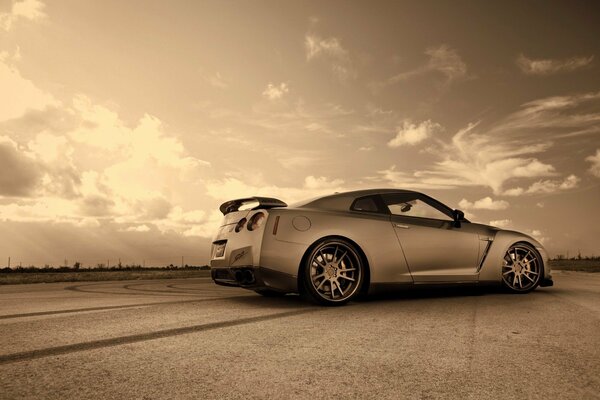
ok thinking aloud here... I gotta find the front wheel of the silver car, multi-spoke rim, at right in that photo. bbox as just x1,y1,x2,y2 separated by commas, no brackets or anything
502,243,544,293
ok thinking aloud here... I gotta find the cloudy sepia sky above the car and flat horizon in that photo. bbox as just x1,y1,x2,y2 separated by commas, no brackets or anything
0,0,600,266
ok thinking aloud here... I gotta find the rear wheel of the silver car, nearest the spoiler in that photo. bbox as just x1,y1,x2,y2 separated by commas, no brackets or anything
303,239,365,306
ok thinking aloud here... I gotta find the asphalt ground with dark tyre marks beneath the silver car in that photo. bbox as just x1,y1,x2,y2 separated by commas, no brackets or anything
0,272,600,399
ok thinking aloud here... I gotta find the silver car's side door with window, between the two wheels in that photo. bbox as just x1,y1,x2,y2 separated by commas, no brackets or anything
382,193,481,283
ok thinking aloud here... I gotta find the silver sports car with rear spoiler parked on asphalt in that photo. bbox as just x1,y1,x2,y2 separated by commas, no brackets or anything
210,189,552,305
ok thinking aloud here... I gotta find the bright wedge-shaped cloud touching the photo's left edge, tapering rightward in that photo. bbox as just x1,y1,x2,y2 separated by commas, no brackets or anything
0,57,58,121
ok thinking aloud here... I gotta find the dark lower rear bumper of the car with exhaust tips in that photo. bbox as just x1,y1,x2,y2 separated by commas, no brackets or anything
210,265,298,293
